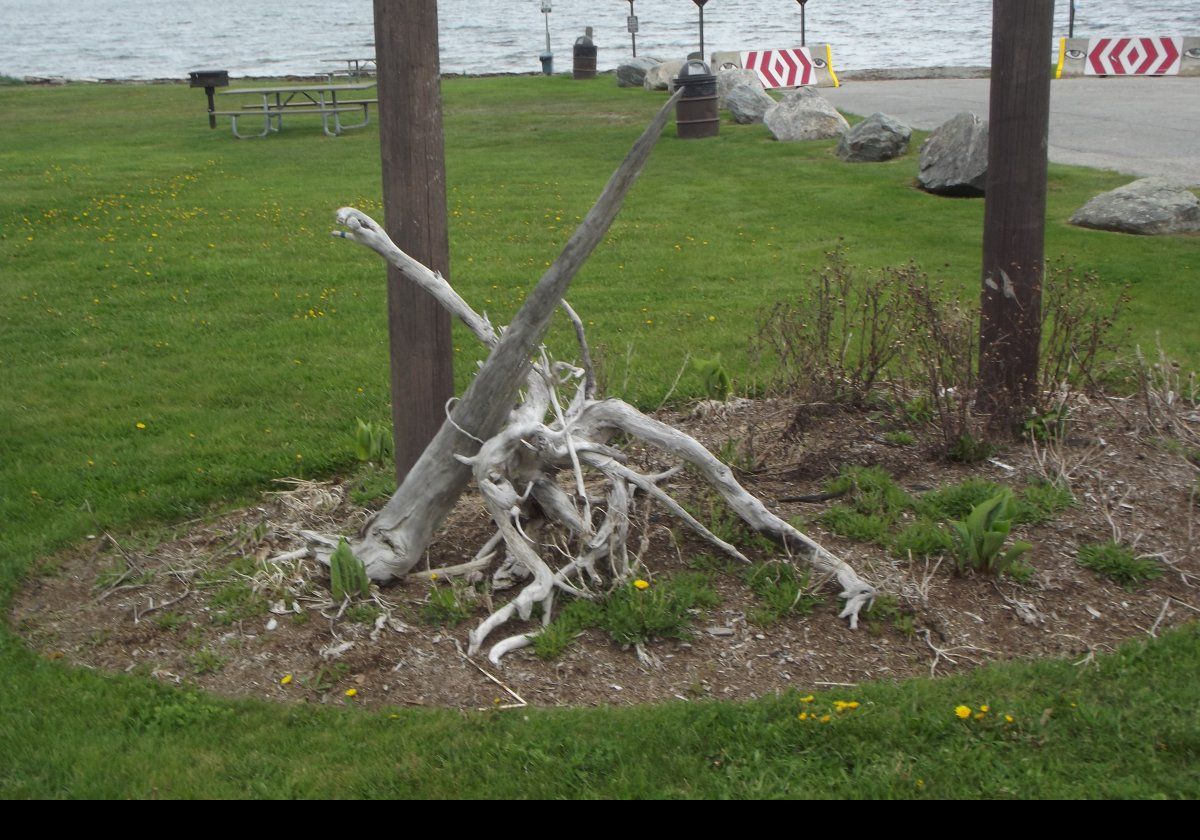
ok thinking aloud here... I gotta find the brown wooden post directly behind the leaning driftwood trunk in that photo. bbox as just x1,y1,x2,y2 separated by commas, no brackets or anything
374,0,454,481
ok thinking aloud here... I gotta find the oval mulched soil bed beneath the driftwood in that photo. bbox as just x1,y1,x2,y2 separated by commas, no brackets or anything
12,400,1200,708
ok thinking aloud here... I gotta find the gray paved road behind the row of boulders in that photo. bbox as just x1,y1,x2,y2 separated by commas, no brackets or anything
821,78,1200,185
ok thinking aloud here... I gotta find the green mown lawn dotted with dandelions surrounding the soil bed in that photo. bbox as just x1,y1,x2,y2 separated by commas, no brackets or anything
0,77,1200,797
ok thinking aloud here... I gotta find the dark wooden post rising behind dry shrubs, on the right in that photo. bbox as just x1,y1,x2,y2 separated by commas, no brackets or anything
978,0,1054,427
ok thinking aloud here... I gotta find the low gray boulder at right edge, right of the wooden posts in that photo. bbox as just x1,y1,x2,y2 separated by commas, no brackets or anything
1070,178,1200,235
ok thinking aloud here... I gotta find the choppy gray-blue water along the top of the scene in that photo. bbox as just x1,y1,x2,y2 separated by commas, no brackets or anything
0,0,1200,79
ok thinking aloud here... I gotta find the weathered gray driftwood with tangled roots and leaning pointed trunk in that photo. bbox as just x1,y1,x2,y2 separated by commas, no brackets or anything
307,94,875,662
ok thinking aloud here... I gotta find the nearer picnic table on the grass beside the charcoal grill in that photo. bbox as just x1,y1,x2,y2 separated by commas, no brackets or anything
212,82,378,139
